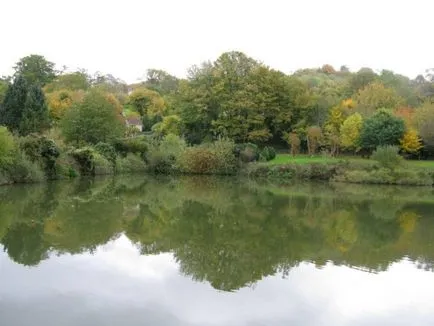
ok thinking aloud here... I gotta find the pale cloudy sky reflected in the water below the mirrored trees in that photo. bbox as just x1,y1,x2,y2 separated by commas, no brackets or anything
0,236,434,326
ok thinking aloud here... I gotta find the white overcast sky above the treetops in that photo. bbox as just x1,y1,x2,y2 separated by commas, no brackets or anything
0,0,434,82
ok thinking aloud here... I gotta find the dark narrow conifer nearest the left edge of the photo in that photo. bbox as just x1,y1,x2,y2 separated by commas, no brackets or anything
0,76,28,131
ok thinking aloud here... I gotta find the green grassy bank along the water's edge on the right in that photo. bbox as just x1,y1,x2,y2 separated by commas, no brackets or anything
244,154,434,186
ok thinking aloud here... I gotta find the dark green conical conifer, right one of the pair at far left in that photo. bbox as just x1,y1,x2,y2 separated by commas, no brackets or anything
19,84,50,135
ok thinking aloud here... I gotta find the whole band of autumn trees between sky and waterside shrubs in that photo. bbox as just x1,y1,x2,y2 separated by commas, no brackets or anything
0,52,434,155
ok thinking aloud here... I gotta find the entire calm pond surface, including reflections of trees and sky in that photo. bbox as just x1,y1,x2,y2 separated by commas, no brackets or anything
0,176,434,326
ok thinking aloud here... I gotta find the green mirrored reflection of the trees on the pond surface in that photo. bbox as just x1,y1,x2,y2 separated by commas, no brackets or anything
0,177,434,291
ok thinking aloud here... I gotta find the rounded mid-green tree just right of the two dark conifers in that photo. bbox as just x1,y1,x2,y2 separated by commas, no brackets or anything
61,90,124,144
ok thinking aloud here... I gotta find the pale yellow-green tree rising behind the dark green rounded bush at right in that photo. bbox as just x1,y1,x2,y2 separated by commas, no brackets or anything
356,82,404,116
